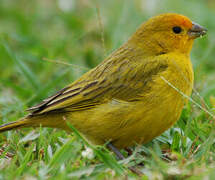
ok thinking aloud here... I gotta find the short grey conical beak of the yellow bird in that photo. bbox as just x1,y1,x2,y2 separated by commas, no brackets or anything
188,22,208,39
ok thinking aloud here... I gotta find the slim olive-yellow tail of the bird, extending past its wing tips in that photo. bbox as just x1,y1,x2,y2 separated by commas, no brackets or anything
0,118,29,133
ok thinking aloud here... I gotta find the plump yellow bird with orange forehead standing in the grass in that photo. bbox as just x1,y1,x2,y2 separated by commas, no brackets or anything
0,13,207,153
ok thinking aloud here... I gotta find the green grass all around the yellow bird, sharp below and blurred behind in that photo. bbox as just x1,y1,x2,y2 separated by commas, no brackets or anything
0,0,215,179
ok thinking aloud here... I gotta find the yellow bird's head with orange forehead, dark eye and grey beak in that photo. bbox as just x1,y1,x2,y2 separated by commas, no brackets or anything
130,13,207,55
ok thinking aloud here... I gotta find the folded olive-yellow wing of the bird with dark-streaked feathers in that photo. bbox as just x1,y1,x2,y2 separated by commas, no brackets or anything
29,55,168,115
